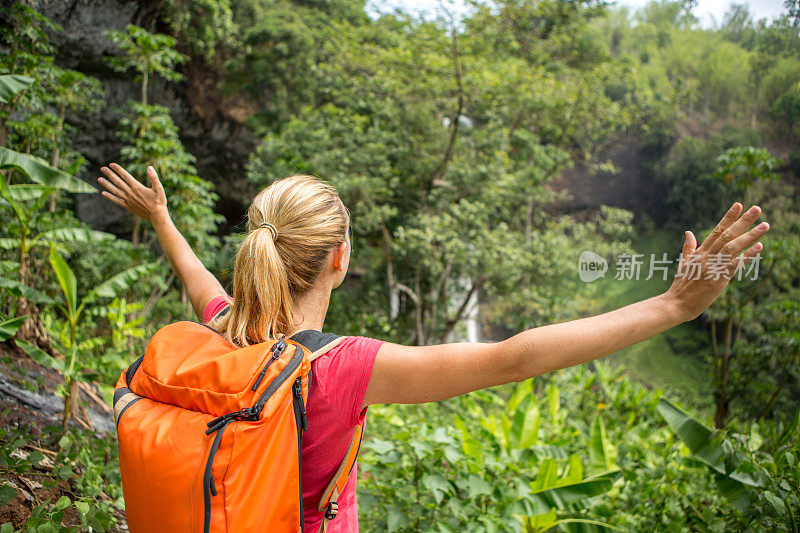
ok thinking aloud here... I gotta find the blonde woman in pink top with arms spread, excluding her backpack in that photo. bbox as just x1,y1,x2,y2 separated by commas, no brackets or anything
99,164,769,531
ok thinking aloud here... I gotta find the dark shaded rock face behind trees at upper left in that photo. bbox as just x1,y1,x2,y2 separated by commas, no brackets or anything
33,0,257,234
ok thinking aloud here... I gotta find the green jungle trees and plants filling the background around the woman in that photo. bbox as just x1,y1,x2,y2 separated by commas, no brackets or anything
0,0,800,533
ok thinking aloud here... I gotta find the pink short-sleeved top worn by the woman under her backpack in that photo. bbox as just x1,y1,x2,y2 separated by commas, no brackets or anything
203,296,383,533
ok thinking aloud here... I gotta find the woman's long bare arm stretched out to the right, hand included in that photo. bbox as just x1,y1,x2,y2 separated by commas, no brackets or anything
364,203,769,407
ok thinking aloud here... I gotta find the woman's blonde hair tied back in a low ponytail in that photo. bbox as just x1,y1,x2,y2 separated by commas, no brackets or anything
211,175,349,346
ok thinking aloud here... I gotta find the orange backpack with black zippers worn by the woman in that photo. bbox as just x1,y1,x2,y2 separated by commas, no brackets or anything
114,321,363,533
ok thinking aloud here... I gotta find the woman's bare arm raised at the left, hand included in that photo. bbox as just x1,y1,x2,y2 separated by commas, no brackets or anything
97,163,225,320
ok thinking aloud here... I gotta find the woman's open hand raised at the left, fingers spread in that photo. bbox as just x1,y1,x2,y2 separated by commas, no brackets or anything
97,163,169,223
